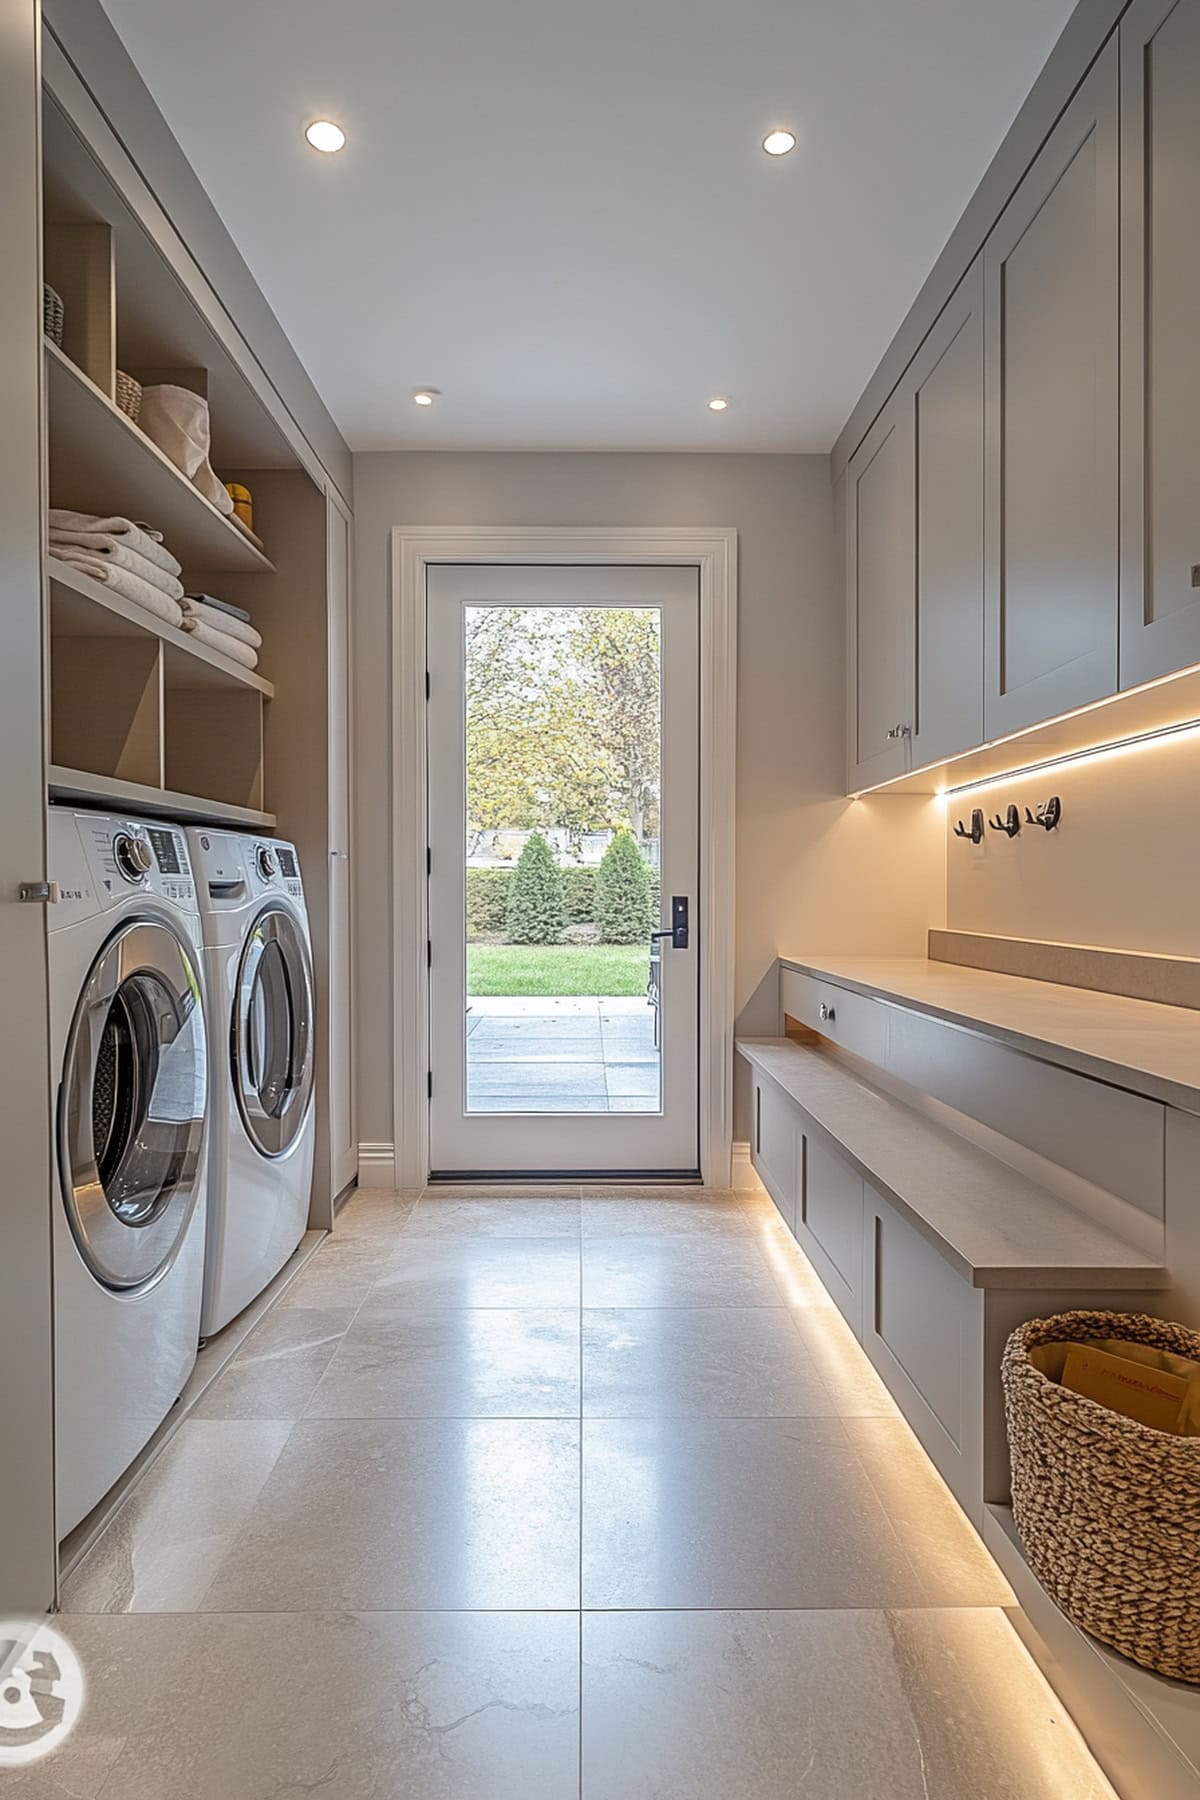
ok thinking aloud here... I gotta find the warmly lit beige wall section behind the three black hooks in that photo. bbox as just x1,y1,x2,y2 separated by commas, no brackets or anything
946,734,1200,956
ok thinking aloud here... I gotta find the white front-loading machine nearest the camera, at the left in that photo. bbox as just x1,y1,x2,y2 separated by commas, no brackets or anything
47,808,209,1535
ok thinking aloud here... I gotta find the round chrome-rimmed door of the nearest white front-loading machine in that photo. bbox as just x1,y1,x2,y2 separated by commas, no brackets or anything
59,920,207,1289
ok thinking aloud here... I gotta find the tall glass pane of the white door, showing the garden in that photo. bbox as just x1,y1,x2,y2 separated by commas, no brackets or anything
464,605,662,1112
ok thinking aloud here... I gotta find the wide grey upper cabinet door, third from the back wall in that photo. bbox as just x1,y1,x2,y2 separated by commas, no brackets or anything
984,36,1121,738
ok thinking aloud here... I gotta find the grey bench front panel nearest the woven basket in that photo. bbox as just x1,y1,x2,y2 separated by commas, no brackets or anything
862,1188,982,1523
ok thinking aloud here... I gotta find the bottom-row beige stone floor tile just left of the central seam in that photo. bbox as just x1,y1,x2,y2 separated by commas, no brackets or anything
73,1613,579,1800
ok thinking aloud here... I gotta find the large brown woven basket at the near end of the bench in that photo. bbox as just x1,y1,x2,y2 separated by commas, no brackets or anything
1002,1312,1200,1683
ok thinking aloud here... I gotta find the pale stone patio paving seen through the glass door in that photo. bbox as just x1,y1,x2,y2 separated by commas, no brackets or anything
466,997,658,1112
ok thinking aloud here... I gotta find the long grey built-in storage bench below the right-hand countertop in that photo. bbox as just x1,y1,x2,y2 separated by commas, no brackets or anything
738,1039,1168,1525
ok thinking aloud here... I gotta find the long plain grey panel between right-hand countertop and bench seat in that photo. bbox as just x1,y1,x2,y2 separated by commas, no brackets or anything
889,1008,1166,1219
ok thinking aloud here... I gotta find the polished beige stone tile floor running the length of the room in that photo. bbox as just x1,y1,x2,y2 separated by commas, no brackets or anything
21,1188,1112,1800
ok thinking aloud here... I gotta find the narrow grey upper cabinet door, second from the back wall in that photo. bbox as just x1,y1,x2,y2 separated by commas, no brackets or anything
905,261,984,767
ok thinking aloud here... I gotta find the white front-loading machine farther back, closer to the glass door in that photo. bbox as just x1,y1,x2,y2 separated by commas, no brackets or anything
189,828,315,1337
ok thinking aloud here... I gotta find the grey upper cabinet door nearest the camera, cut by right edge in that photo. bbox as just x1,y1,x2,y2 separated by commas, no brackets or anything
1121,0,1200,688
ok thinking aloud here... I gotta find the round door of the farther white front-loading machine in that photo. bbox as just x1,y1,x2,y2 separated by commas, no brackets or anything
230,905,313,1156
